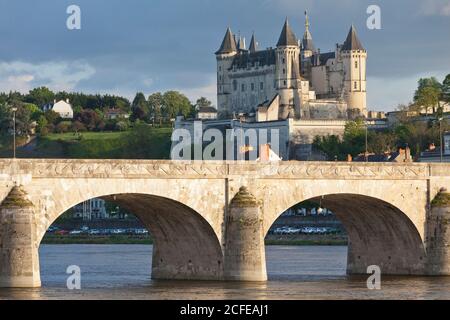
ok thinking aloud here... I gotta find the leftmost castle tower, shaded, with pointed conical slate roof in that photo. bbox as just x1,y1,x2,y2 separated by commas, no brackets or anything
216,28,238,114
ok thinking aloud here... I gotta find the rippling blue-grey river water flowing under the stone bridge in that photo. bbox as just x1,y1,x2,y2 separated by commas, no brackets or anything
0,245,450,300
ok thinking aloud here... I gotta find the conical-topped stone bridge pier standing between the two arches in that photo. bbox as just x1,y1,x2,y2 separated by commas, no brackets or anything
224,187,267,281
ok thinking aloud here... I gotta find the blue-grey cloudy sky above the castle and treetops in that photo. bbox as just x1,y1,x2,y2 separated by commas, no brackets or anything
0,0,450,111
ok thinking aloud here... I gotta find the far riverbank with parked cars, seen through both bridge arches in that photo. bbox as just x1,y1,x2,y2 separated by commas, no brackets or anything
42,234,347,246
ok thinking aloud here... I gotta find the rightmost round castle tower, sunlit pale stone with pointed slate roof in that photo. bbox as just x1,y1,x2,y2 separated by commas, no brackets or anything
341,25,367,116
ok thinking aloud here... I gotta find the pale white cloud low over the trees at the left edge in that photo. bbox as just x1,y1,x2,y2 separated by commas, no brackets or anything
0,61,95,92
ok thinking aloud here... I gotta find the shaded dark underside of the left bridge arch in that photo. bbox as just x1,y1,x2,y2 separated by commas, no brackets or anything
42,193,223,280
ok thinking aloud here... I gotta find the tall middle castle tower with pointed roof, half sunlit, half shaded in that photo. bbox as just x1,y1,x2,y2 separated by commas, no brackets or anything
275,19,300,118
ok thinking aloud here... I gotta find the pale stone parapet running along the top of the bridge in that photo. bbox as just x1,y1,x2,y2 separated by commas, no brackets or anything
0,159,450,179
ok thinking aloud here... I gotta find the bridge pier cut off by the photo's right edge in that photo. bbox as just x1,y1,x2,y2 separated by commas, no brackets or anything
426,191,450,276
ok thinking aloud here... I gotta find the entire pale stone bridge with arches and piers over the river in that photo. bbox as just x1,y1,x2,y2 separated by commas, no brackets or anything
0,159,450,287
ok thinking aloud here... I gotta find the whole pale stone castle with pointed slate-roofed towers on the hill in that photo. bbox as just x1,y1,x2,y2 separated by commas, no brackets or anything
215,12,367,122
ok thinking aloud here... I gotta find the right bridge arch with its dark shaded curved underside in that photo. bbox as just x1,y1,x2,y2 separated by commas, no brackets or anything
265,193,426,275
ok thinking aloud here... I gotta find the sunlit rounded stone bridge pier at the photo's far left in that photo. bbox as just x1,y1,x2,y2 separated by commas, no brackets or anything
0,187,41,288
